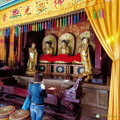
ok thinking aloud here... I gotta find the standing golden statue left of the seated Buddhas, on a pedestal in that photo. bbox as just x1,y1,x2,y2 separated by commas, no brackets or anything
26,43,38,76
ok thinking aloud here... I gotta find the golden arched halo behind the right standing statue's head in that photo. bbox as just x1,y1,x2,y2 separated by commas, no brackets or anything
75,31,94,54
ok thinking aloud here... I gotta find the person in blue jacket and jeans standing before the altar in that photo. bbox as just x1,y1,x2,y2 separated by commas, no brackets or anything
28,73,47,120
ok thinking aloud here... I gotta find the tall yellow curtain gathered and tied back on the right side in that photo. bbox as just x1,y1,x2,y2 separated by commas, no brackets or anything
85,0,120,120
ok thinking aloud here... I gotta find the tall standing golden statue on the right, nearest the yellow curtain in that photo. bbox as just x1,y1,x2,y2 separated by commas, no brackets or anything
78,37,92,82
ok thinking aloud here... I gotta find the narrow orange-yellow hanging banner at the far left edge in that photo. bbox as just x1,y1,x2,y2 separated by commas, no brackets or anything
0,31,5,60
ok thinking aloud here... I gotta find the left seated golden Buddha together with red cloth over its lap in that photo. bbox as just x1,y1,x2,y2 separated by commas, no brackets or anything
40,41,54,63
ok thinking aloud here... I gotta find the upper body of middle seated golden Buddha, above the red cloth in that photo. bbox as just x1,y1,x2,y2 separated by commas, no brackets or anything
60,40,70,55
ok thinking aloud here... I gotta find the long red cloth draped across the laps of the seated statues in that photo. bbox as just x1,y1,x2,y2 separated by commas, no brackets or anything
39,53,81,63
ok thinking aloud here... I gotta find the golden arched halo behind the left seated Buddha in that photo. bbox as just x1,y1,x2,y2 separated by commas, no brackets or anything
42,35,57,55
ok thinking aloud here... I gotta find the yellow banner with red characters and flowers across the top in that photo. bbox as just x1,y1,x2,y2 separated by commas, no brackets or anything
0,0,104,28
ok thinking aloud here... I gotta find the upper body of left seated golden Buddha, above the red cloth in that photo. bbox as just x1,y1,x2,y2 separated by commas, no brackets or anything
43,41,54,55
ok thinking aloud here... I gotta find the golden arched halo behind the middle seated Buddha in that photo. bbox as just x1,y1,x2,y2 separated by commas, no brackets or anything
58,33,75,55
